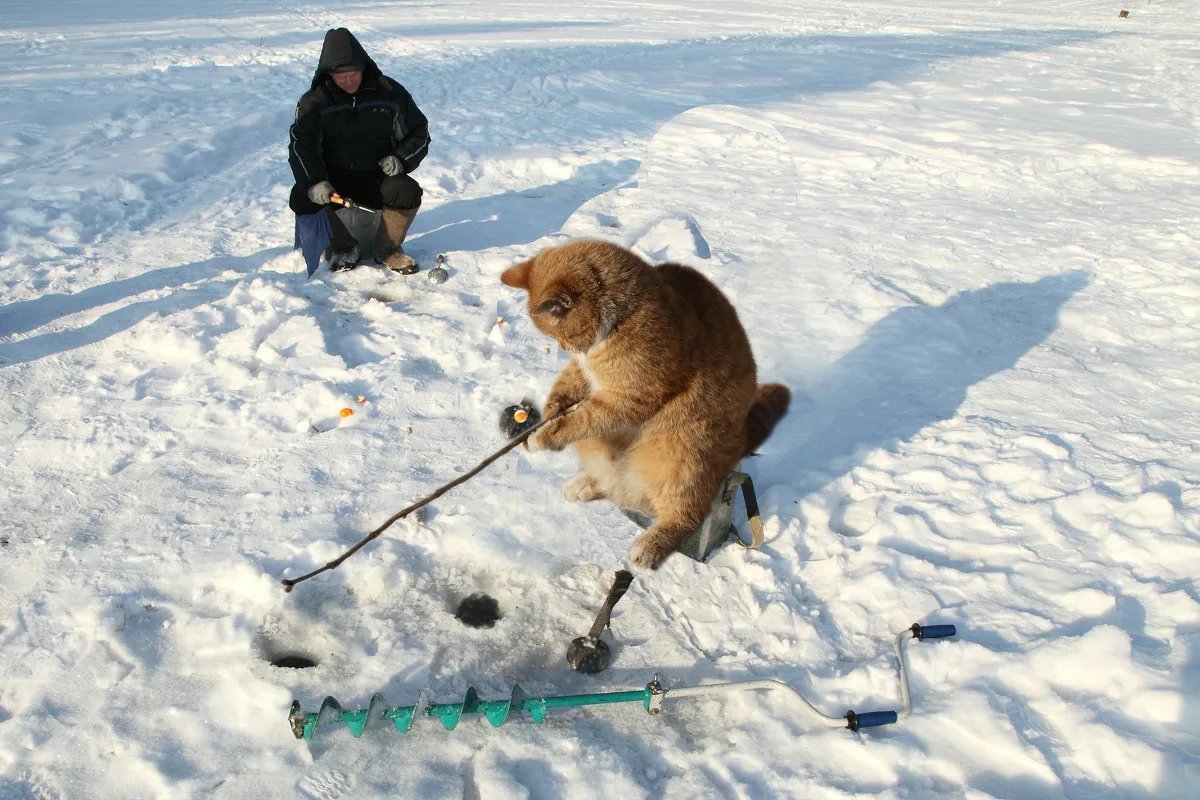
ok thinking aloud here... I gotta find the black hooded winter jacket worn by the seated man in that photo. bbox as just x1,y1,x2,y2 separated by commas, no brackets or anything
288,28,430,187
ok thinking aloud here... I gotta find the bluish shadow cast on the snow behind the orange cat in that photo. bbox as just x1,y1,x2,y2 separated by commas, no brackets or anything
769,270,1088,491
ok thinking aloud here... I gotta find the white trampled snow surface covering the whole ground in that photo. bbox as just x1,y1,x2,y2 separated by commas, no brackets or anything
0,0,1200,800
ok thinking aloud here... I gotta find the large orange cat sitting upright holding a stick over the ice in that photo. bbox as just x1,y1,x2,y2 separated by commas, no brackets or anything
500,240,791,569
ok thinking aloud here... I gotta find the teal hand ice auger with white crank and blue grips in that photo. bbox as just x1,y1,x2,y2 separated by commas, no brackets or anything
288,624,956,739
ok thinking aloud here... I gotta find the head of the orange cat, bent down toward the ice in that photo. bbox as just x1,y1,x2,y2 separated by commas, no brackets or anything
500,239,650,353
